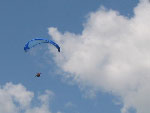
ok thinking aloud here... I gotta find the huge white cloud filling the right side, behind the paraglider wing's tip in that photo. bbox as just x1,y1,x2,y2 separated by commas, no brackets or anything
49,0,150,113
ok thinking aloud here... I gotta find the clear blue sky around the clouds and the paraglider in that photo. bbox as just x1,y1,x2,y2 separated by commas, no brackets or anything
0,0,150,113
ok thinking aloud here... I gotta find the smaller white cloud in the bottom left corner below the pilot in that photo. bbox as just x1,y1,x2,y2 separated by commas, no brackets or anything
0,83,54,113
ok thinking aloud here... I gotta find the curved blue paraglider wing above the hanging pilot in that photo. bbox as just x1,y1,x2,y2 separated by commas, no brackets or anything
24,38,60,52
